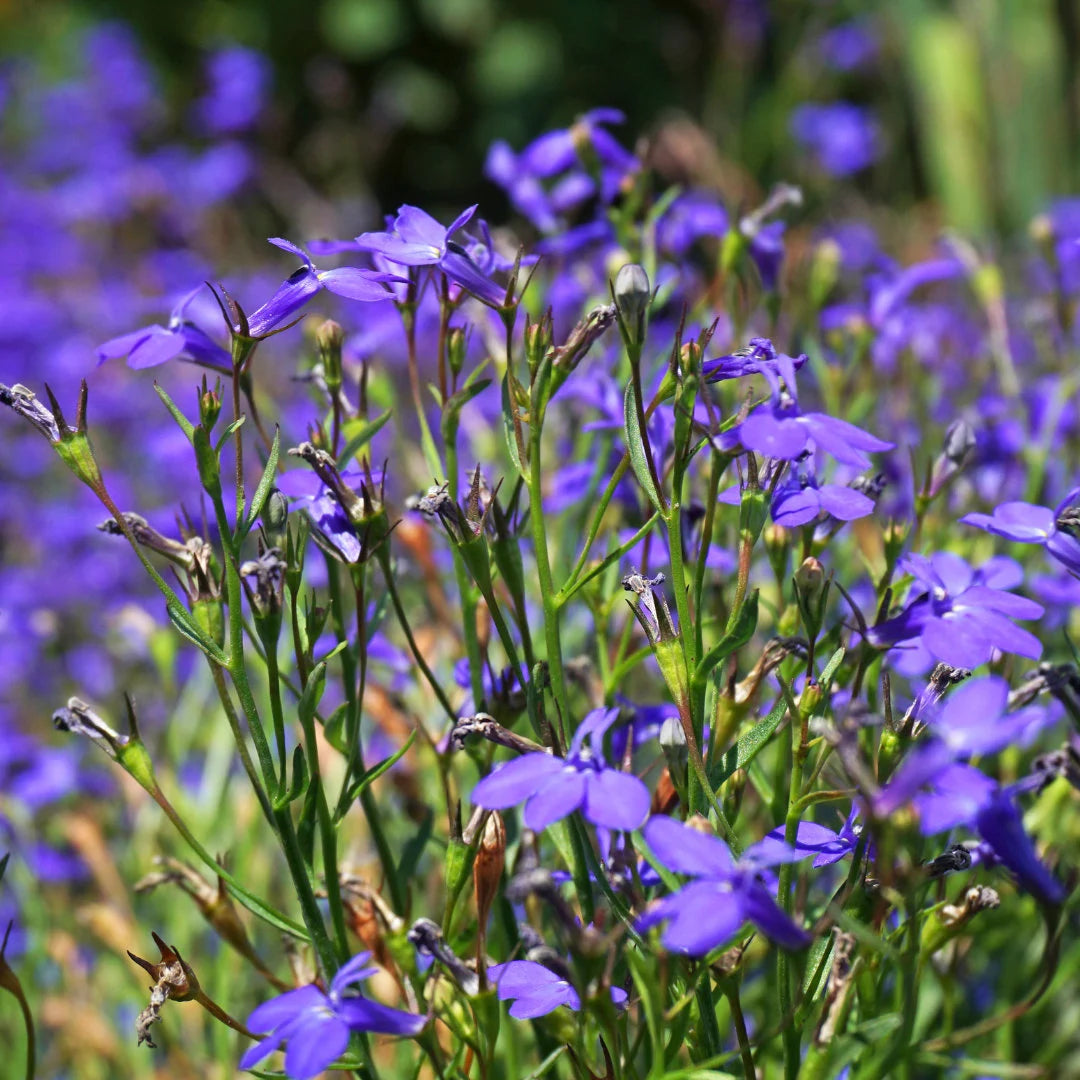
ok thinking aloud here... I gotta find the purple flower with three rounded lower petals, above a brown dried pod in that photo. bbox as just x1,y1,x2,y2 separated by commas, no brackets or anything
473,708,649,833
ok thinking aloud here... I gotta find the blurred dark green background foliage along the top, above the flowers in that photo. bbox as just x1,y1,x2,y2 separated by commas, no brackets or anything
8,0,1080,237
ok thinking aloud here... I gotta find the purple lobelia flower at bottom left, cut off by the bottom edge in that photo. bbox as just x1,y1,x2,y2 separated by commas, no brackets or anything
240,953,427,1080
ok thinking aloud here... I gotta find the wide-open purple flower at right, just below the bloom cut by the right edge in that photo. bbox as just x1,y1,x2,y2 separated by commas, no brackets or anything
869,552,1042,667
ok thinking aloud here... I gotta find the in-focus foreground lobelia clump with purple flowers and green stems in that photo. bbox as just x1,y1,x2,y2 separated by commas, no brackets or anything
0,63,1080,1080
